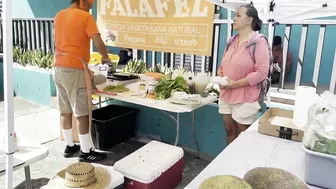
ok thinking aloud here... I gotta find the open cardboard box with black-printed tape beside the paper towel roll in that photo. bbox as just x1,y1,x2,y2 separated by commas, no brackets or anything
258,108,304,142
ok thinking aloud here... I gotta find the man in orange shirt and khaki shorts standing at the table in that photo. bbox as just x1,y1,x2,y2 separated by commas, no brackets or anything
54,0,110,162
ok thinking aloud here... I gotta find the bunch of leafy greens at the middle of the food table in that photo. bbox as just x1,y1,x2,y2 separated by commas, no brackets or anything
154,76,189,100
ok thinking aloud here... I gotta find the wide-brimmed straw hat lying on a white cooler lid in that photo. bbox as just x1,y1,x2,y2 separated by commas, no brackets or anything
48,162,111,189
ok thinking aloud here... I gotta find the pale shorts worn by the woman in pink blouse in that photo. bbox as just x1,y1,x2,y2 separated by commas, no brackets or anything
218,100,260,125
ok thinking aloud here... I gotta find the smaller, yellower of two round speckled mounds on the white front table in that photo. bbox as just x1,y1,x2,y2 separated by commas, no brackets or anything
199,175,252,189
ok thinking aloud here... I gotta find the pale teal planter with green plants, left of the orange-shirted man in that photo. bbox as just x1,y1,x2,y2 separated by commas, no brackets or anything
13,46,56,106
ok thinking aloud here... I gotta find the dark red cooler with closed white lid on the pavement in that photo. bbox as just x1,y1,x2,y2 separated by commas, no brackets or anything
114,141,184,189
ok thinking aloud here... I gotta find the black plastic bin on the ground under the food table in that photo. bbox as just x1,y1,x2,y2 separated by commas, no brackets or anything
91,105,139,150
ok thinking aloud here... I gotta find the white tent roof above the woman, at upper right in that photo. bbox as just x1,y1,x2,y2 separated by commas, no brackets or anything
208,0,336,22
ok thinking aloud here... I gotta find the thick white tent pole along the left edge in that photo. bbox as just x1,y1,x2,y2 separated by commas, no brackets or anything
2,0,14,189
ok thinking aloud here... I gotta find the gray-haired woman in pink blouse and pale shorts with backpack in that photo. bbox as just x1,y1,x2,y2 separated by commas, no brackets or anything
218,5,270,144
